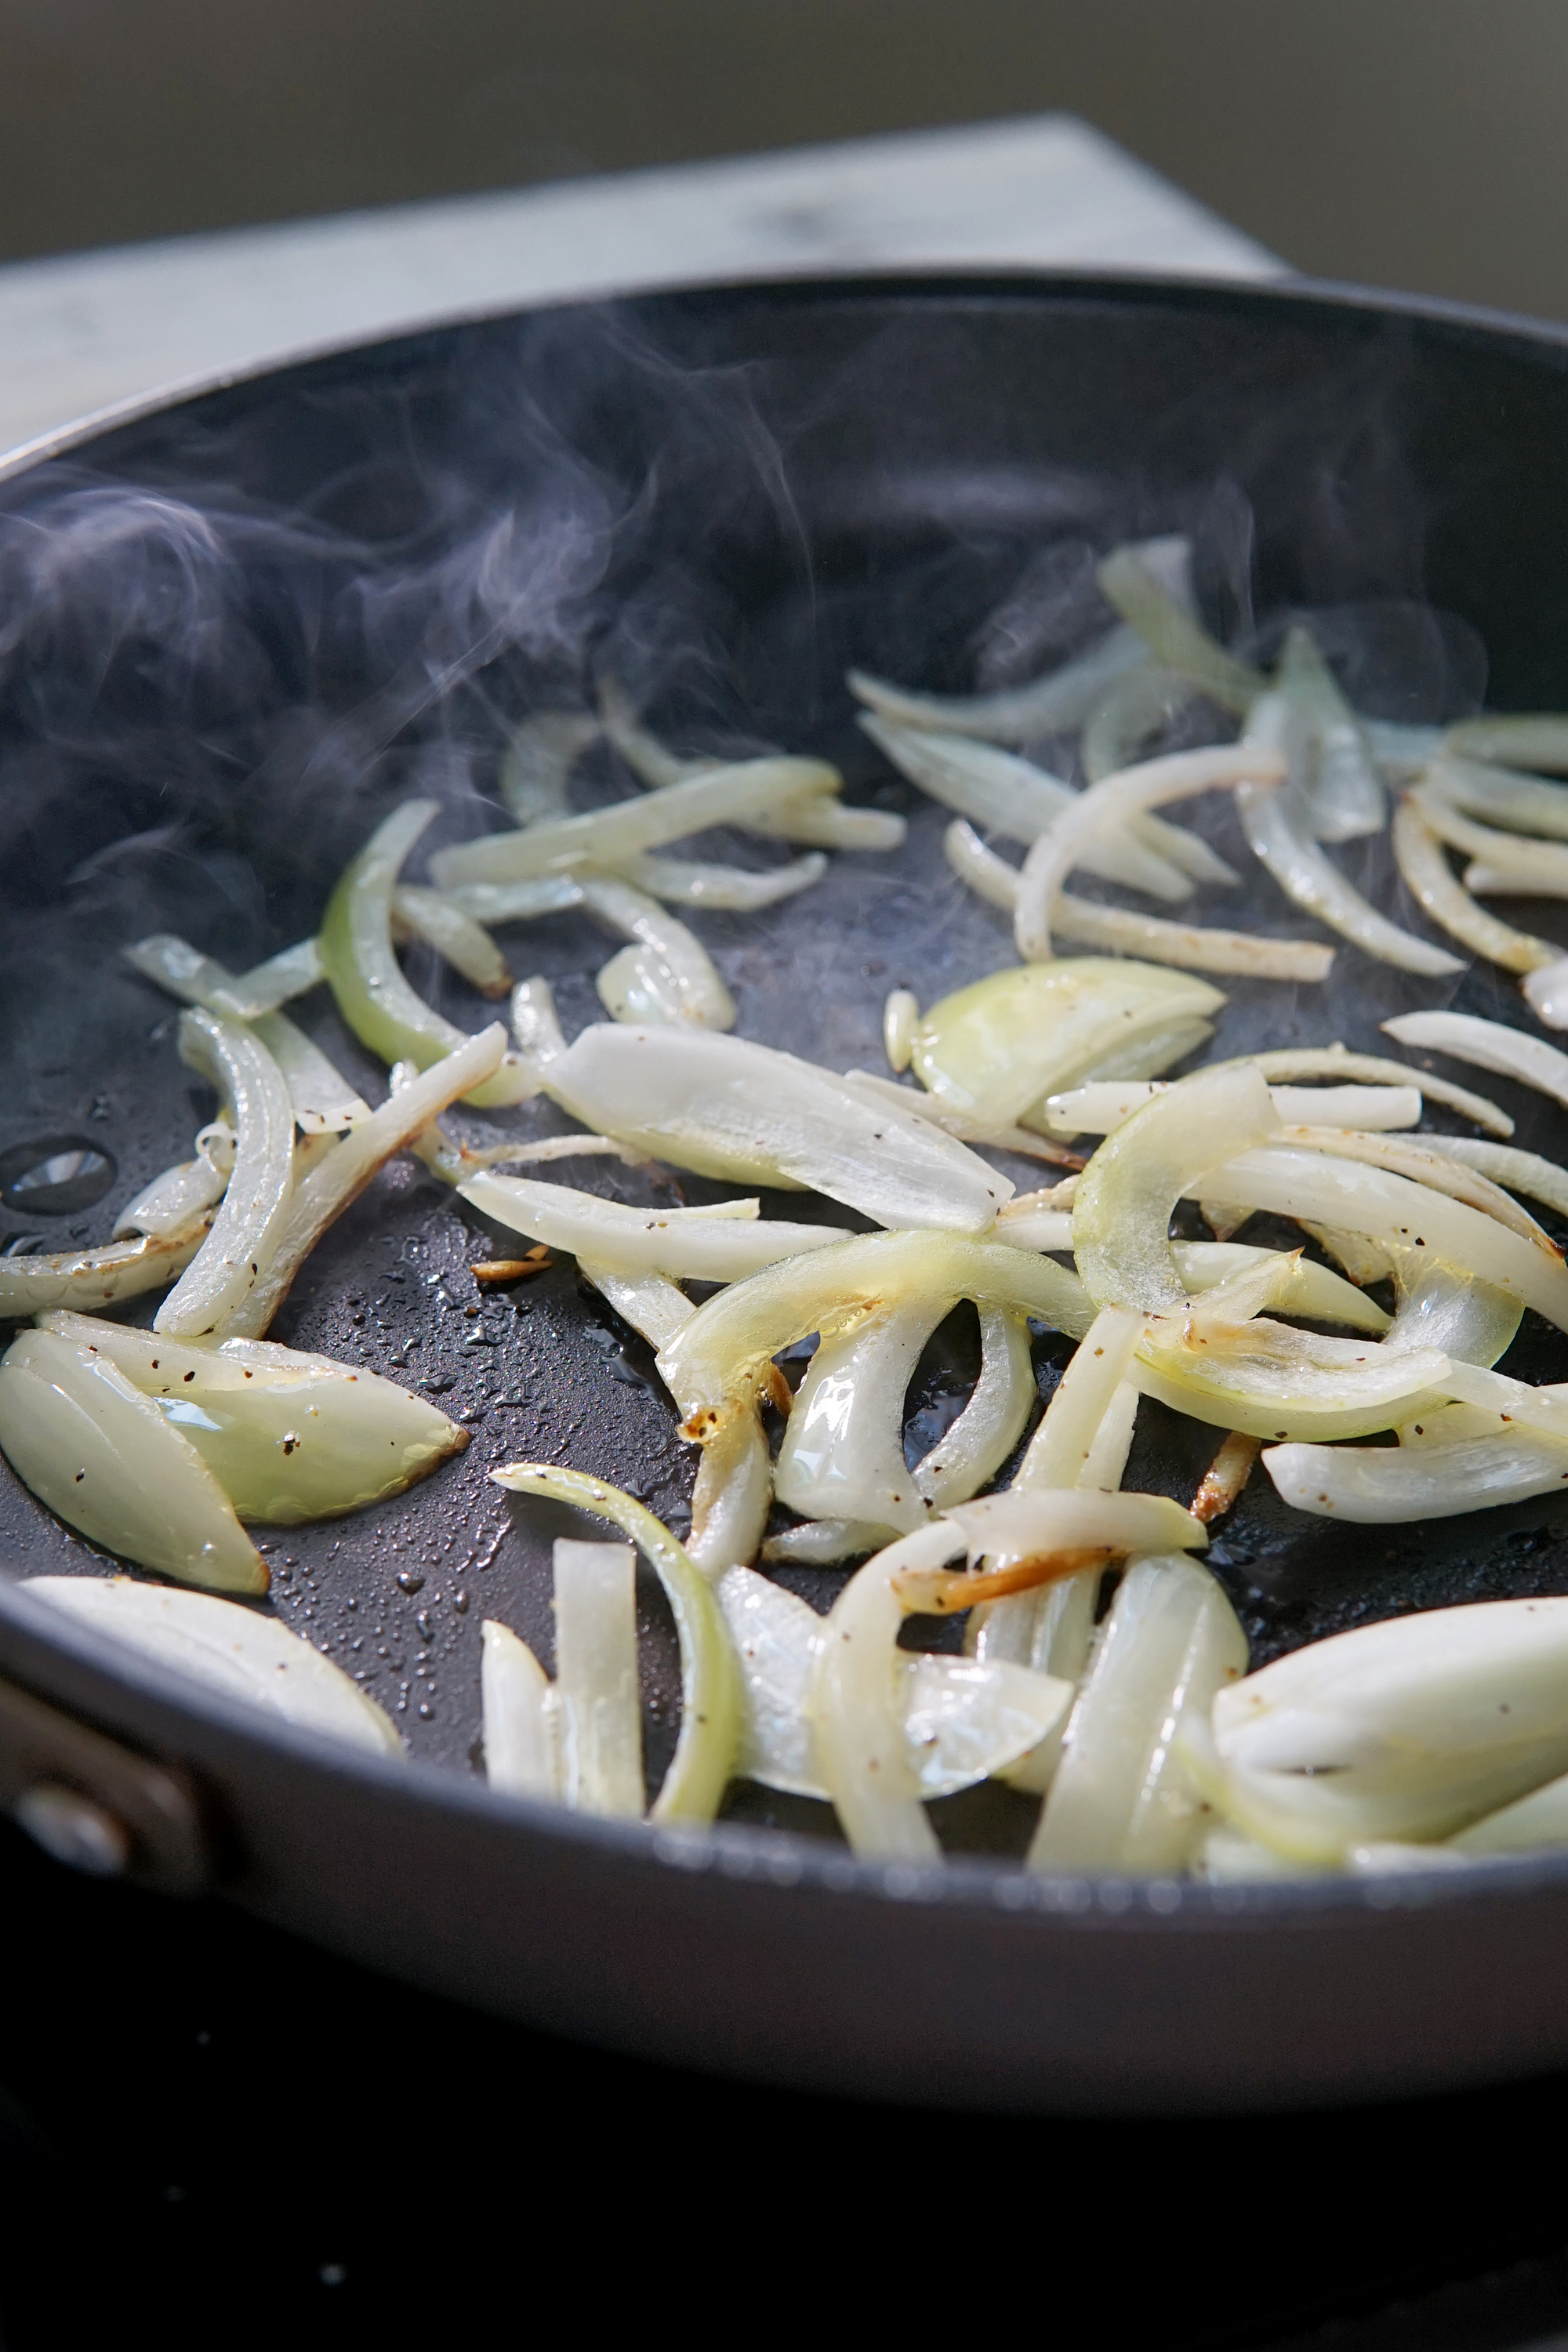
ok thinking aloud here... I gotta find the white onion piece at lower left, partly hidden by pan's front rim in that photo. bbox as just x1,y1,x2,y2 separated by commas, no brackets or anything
21,1576,405,1757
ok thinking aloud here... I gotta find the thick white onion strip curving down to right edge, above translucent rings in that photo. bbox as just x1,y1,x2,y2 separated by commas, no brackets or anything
1189,1143,1568,1329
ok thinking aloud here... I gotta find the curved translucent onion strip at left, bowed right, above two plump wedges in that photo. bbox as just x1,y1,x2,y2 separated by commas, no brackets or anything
153,1009,294,1338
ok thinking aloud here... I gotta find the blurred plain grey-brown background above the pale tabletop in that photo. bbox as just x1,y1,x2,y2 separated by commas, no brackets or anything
0,0,1568,318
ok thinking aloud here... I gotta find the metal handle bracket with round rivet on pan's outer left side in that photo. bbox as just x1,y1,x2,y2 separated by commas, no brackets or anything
0,1682,212,1893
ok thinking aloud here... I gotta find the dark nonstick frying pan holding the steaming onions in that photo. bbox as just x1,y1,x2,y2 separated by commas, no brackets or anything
0,278,1568,2112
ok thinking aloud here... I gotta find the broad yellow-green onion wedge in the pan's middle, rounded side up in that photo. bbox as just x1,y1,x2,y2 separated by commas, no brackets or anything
909,957,1225,1127
